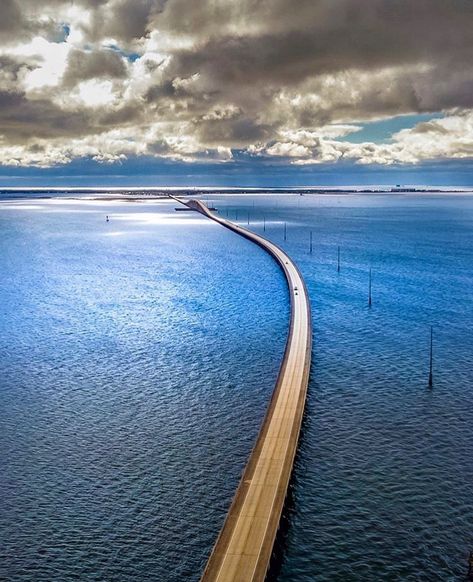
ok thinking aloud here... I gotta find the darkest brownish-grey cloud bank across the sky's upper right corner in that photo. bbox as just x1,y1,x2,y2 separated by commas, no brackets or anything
162,0,473,101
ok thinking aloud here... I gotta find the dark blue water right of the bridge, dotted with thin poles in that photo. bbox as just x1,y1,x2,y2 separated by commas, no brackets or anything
214,195,473,582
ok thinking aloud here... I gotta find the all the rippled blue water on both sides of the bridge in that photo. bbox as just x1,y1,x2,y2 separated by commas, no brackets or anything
0,194,473,582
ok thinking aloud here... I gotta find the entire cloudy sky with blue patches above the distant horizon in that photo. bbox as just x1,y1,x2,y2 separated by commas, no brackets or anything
0,0,473,185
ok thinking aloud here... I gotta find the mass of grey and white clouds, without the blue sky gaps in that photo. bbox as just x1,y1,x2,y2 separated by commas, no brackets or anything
0,0,473,163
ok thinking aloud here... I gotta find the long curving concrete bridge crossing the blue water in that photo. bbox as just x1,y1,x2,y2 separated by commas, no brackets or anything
173,197,312,582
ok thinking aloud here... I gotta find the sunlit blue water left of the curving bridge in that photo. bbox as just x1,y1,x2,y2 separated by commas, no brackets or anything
0,201,288,582
